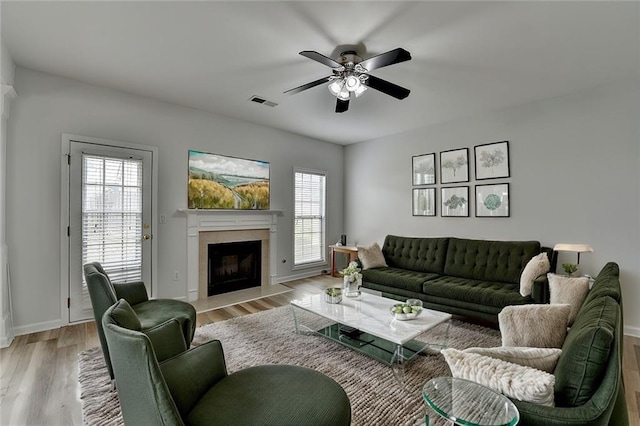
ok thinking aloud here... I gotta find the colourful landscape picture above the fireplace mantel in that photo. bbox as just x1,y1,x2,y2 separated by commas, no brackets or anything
187,150,269,210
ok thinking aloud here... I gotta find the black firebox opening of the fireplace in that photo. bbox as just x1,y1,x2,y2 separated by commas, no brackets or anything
207,240,262,296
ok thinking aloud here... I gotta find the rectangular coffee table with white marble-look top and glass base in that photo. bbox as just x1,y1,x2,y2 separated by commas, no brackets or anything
291,292,451,373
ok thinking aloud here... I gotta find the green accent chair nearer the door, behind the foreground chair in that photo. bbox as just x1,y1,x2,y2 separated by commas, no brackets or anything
84,262,196,380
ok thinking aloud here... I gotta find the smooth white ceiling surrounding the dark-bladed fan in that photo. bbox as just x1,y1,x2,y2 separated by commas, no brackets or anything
1,1,640,144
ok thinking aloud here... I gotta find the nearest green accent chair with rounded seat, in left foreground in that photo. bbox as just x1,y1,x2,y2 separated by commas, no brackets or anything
102,300,351,426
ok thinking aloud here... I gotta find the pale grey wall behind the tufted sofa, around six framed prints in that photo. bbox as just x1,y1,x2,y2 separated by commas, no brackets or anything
345,81,640,336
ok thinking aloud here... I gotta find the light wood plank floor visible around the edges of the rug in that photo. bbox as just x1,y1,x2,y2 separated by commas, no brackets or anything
0,276,640,426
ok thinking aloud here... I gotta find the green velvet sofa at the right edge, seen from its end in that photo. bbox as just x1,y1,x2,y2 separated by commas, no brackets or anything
513,262,629,426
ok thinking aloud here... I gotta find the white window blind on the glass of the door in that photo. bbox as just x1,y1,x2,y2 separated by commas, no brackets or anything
82,154,142,286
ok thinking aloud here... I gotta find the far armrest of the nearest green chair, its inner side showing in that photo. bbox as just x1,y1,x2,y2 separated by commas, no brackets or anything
160,340,227,418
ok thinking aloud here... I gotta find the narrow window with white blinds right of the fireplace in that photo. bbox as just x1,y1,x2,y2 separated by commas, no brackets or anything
293,170,326,266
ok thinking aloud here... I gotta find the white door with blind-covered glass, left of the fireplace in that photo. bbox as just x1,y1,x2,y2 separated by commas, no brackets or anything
68,141,153,322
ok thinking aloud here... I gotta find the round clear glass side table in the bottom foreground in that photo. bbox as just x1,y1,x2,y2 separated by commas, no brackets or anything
422,377,520,426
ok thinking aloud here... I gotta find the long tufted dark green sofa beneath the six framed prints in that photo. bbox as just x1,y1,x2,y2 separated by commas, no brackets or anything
362,235,555,324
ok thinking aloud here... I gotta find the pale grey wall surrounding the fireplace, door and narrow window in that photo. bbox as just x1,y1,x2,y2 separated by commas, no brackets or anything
7,67,344,334
